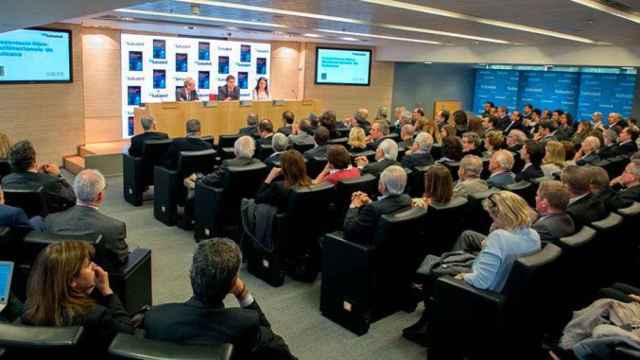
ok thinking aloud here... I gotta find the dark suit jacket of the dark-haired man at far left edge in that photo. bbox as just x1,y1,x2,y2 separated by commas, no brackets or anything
2,171,76,213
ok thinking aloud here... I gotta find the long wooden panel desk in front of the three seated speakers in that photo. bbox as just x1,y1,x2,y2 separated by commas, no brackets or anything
134,100,321,139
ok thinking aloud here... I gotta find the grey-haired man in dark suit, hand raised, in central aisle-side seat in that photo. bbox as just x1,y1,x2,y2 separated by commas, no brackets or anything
344,166,411,244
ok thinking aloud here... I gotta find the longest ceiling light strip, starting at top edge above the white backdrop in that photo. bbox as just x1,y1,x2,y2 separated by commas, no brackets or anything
176,0,510,44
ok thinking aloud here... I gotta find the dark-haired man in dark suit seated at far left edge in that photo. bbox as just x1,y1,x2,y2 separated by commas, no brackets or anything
2,140,76,213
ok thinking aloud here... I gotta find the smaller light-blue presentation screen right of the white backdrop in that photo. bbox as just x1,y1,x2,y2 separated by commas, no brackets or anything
315,47,371,86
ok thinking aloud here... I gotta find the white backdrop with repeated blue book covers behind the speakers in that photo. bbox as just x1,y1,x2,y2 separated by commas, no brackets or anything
120,34,271,138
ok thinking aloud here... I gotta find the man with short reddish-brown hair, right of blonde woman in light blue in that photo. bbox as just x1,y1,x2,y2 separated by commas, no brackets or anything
531,180,575,241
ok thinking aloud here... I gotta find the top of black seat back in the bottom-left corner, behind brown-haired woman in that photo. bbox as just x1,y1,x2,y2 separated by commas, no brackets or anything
0,323,84,349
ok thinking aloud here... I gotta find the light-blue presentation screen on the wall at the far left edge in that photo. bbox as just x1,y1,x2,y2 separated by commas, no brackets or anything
0,29,72,83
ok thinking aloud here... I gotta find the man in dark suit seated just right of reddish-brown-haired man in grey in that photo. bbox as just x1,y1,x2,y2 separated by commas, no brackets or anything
560,165,609,229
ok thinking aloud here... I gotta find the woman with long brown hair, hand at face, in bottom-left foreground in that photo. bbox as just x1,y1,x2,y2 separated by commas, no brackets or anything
21,241,134,354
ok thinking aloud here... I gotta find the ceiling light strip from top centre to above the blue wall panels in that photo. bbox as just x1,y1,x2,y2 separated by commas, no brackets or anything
360,0,596,44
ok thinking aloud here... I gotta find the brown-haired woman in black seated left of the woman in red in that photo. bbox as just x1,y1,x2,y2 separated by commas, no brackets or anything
256,149,312,211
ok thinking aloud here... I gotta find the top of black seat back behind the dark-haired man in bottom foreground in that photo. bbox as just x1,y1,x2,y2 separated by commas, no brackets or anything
109,334,233,360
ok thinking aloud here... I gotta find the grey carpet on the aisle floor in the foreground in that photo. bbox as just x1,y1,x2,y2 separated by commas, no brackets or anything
102,176,426,360
